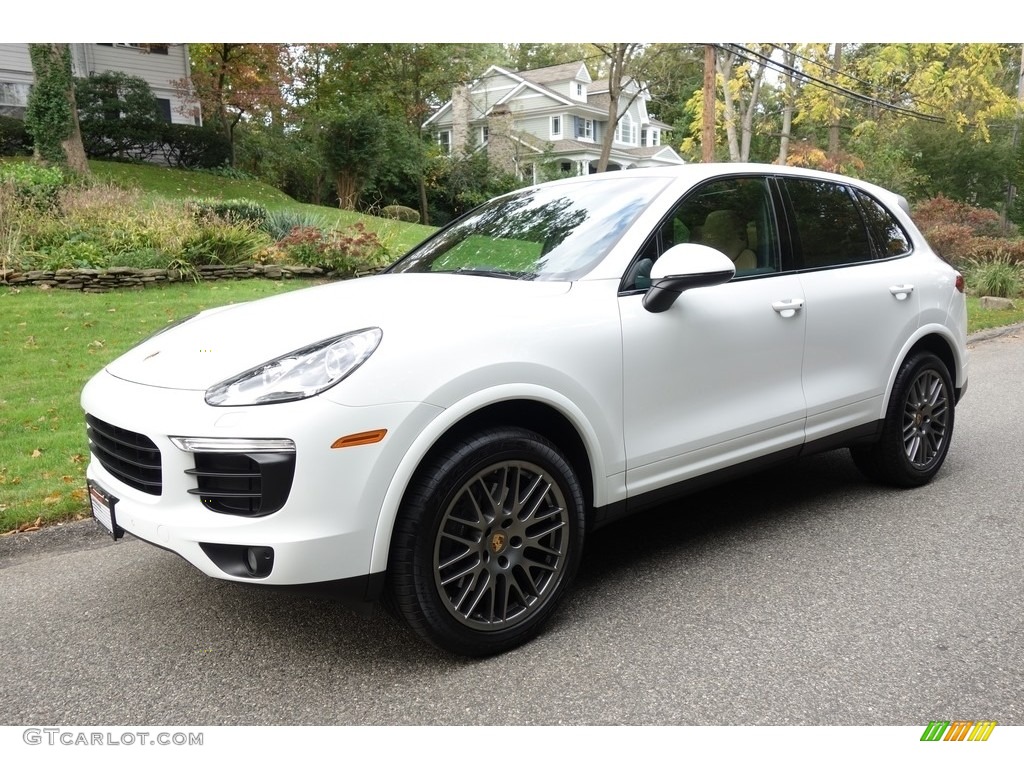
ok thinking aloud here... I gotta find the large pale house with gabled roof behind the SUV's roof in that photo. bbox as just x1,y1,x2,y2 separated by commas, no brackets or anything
424,61,684,179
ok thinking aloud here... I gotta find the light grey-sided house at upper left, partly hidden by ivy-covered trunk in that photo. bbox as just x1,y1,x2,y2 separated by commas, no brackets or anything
0,43,201,125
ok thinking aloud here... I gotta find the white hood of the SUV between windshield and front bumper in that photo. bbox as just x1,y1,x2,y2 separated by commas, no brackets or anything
106,273,571,390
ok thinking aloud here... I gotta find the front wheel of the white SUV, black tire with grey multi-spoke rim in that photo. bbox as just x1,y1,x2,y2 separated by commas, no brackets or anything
388,427,585,656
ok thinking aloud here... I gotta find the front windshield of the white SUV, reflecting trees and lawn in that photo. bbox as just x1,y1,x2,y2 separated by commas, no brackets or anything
391,174,668,281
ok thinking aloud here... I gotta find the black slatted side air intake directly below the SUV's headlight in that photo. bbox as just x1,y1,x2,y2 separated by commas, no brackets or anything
185,453,295,517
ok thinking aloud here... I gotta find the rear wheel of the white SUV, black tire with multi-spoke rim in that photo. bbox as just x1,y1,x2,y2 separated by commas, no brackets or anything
850,352,955,488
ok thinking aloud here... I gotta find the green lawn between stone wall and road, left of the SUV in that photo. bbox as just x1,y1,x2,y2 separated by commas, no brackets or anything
0,280,319,534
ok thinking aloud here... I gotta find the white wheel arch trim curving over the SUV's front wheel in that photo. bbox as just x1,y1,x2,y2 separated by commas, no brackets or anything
370,392,605,573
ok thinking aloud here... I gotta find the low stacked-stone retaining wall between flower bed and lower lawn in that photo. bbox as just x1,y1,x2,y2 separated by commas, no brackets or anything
0,264,369,293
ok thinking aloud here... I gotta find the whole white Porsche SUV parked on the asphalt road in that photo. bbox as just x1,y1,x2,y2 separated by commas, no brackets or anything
82,164,968,655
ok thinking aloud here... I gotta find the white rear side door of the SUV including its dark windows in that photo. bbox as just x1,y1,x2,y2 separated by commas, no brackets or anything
779,178,921,441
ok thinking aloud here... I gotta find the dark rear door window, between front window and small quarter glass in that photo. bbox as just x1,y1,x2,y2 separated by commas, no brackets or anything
783,178,874,269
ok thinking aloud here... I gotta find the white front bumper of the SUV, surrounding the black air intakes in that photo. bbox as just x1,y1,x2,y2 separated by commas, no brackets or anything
82,372,440,585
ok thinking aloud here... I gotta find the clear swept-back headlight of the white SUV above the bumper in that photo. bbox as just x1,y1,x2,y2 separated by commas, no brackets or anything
206,328,383,406
